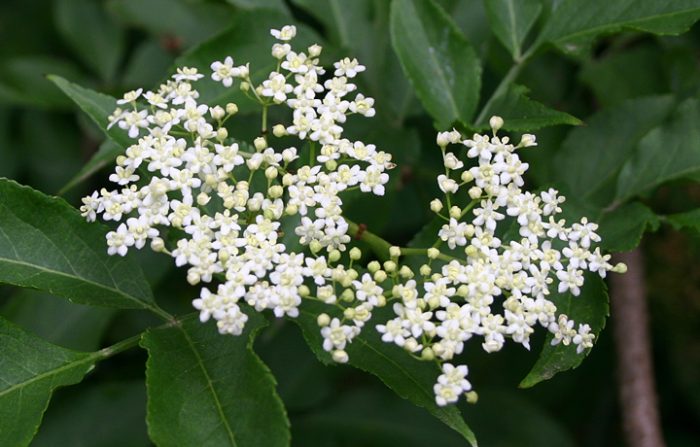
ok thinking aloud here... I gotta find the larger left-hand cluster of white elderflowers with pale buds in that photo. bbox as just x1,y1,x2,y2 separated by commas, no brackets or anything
81,26,393,340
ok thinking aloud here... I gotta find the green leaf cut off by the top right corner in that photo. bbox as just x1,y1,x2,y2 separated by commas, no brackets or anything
538,0,700,52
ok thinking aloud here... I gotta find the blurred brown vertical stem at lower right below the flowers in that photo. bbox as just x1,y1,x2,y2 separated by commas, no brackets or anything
611,248,665,447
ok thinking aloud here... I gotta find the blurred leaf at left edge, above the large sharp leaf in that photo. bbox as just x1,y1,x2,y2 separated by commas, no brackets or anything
0,56,83,109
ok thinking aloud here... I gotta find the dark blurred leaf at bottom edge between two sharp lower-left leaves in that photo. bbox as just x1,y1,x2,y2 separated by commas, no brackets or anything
32,380,152,447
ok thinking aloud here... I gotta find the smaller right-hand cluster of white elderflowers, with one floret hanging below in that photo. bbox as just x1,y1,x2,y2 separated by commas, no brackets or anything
377,117,625,405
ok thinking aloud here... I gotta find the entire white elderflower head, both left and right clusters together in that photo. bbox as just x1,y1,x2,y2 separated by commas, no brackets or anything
81,26,623,405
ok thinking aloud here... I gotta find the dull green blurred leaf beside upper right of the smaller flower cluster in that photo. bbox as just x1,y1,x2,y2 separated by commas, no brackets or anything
554,96,674,206
